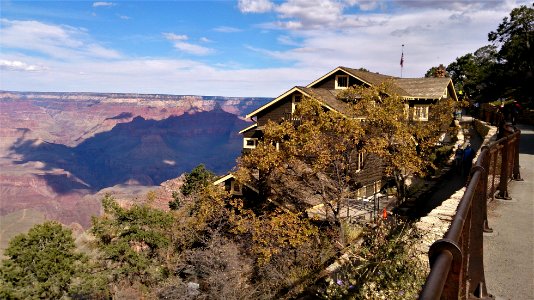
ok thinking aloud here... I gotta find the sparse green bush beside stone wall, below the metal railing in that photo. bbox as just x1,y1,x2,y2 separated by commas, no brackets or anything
319,222,425,300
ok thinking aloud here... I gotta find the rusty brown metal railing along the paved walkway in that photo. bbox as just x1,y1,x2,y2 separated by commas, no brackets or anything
419,126,521,300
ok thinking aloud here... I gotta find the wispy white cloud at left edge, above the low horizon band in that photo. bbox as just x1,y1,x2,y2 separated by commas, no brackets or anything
0,19,121,60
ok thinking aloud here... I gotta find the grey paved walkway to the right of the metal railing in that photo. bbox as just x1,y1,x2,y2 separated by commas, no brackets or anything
484,125,534,300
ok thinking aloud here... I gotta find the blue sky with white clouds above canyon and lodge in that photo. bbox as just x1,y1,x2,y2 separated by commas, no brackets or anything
0,0,531,97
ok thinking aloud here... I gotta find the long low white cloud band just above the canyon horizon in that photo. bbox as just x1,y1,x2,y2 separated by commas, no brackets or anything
0,53,312,97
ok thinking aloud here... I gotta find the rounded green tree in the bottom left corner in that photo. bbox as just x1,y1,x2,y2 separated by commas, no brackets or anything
0,221,87,299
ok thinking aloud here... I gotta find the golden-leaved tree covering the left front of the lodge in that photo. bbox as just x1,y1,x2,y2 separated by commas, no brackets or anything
237,98,363,243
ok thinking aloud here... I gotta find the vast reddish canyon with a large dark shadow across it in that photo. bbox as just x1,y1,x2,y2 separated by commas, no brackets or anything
0,91,270,251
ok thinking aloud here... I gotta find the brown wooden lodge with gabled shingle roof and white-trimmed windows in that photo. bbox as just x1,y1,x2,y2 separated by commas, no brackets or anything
214,66,458,205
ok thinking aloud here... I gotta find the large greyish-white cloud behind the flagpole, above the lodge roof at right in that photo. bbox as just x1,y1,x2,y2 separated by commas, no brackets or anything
248,1,528,79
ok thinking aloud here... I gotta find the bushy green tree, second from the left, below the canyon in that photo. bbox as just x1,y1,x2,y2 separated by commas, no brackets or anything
91,195,174,285
